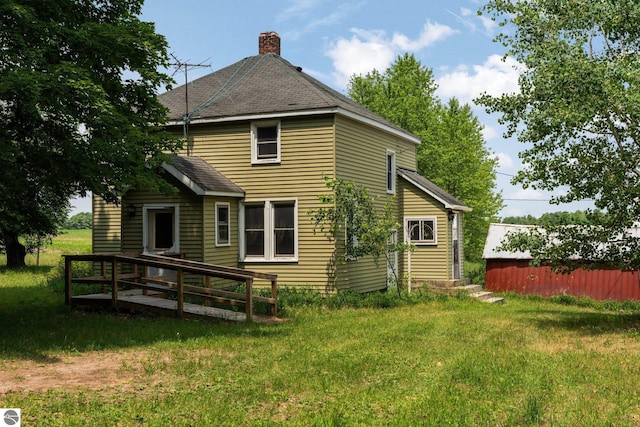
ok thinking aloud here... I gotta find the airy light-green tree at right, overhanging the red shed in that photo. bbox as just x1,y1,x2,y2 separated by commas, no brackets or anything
478,0,640,267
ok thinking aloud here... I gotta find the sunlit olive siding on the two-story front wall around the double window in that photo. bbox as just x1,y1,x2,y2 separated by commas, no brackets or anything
179,115,335,291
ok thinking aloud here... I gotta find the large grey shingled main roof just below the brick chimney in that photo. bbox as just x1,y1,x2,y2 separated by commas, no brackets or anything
158,53,420,144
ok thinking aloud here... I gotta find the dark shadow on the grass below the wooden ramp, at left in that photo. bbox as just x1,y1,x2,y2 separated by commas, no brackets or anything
0,286,287,363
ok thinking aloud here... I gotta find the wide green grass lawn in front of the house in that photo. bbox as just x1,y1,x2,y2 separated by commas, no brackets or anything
0,232,640,426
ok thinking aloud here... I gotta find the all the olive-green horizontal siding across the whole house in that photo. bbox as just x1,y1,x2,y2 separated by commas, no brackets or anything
94,109,462,292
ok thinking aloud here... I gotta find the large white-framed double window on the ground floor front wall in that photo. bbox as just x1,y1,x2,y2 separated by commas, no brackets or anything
241,200,298,261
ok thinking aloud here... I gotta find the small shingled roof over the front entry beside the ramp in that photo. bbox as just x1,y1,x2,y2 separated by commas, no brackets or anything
162,154,244,197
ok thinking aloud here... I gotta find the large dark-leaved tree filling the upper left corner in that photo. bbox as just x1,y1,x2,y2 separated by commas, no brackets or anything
0,0,180,267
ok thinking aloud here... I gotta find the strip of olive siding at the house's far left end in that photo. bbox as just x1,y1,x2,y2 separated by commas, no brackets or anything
91,195,121,254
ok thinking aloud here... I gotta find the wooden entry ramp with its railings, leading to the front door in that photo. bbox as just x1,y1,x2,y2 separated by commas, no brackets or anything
64,254,277,322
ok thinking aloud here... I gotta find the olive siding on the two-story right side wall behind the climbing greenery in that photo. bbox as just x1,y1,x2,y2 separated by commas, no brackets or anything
336,116,416,292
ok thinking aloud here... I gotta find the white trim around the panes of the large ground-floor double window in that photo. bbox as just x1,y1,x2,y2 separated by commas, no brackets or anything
238,198,299,262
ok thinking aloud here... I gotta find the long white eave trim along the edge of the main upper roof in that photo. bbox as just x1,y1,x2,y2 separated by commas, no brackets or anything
162,107,421,145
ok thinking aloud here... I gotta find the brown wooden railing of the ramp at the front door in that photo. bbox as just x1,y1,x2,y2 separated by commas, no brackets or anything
64,254,278,321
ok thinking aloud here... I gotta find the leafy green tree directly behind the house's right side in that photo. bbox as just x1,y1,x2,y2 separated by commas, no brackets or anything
348,54,502,260
